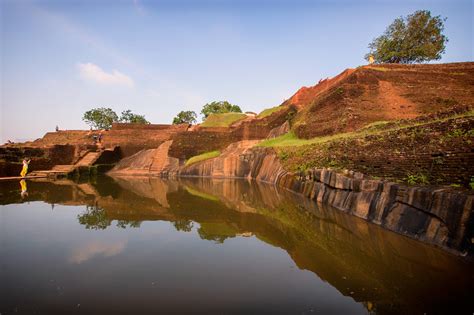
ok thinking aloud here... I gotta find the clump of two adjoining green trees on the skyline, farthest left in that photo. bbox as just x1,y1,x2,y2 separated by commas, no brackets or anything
82,107,150,129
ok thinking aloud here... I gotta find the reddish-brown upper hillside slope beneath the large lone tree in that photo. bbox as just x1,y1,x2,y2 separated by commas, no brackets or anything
283,62,474,139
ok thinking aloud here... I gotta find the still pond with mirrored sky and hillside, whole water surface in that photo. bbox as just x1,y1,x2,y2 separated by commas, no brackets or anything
0,177,474,315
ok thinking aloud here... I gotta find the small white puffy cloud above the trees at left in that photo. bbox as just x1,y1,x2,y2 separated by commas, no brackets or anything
77,63,134,87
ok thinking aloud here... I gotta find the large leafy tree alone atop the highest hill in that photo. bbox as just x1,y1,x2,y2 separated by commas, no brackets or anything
365,10,448,64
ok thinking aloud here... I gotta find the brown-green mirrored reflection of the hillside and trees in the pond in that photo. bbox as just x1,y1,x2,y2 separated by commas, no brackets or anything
0,177,474,314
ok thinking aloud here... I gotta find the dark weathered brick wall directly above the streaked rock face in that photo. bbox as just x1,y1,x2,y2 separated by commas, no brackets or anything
283,117,474,186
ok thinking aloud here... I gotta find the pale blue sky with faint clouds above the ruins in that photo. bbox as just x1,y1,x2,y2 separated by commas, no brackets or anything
0,0,474,143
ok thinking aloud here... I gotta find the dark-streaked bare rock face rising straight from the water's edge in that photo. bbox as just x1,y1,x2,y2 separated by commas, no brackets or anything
176,147,474,254
